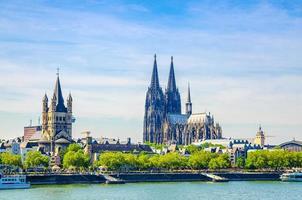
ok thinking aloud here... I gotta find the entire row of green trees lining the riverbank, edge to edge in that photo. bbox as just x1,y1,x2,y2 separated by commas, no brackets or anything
0,144,302,171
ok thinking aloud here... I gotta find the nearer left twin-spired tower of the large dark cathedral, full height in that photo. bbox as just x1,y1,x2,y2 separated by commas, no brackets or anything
143,55,165,144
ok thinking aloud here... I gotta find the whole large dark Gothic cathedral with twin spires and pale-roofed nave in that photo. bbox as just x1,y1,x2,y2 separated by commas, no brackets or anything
143,55,222,145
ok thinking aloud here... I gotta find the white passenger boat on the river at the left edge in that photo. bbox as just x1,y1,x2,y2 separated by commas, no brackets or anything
0,174,30,190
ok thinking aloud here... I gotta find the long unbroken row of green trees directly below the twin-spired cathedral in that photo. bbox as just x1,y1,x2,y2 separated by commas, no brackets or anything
95,151,230,171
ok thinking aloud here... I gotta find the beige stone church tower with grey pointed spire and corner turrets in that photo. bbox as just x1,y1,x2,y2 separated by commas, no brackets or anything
39,73,73,153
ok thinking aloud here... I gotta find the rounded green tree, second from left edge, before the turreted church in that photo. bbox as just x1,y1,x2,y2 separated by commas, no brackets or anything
24,151,49,168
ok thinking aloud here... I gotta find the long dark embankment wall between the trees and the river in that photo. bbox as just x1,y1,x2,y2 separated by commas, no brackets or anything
27,172,280,185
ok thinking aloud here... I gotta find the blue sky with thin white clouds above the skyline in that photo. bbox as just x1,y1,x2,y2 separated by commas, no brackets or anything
0,0,302,144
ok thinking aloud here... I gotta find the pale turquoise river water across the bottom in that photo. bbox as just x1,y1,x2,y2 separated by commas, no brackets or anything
0,181,302,200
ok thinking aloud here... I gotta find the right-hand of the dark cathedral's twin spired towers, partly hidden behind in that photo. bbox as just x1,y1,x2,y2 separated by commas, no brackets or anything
165,56,181,114
